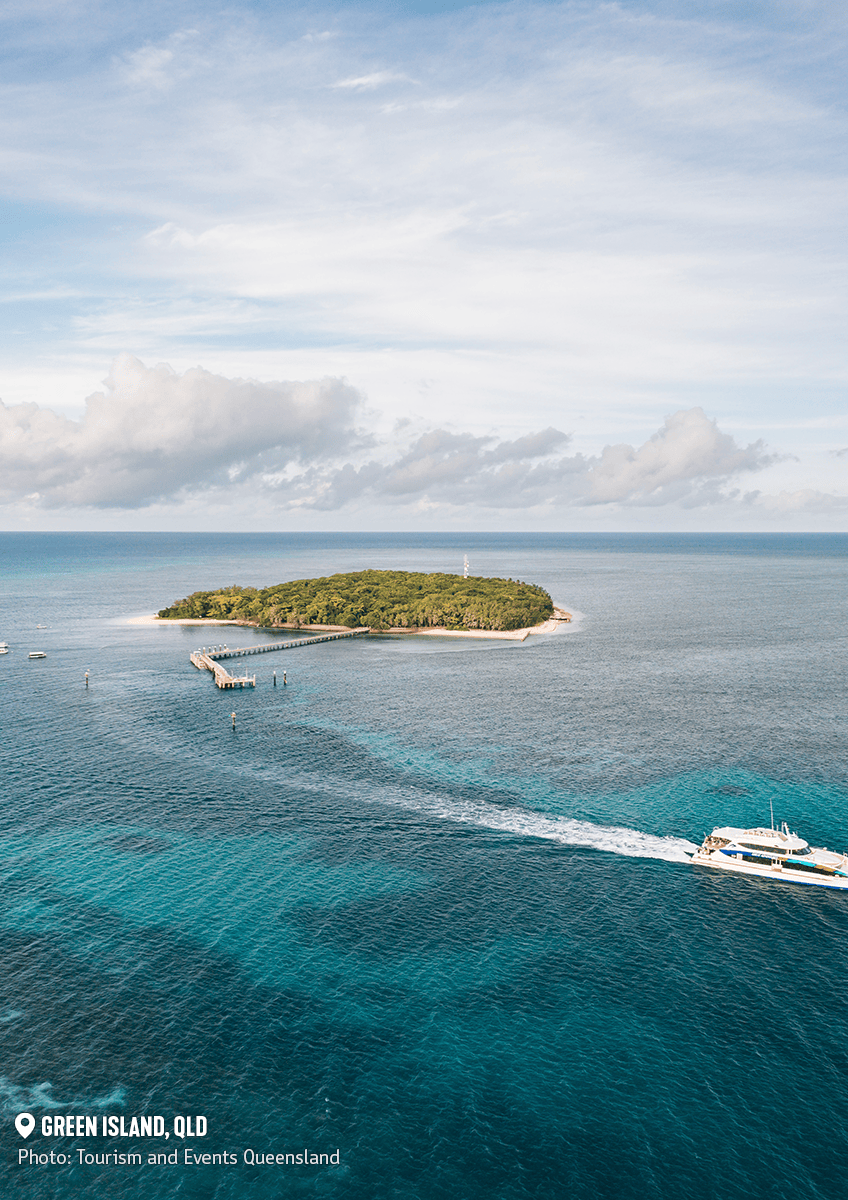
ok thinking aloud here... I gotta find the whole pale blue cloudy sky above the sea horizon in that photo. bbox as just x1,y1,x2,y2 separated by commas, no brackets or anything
0,0,848,532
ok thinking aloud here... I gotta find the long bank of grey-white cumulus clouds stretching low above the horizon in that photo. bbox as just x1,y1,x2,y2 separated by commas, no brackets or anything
0,354,774,511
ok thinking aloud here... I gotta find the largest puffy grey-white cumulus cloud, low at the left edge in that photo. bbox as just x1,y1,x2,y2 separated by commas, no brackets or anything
0,354,362,508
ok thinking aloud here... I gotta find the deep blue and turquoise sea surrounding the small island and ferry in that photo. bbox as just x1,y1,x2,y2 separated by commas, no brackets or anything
0,534,848,1200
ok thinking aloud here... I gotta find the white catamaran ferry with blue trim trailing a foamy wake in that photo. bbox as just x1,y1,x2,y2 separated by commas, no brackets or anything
692,821,848,888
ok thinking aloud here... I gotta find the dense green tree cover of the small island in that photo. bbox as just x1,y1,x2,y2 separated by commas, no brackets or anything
160,571,553,631
